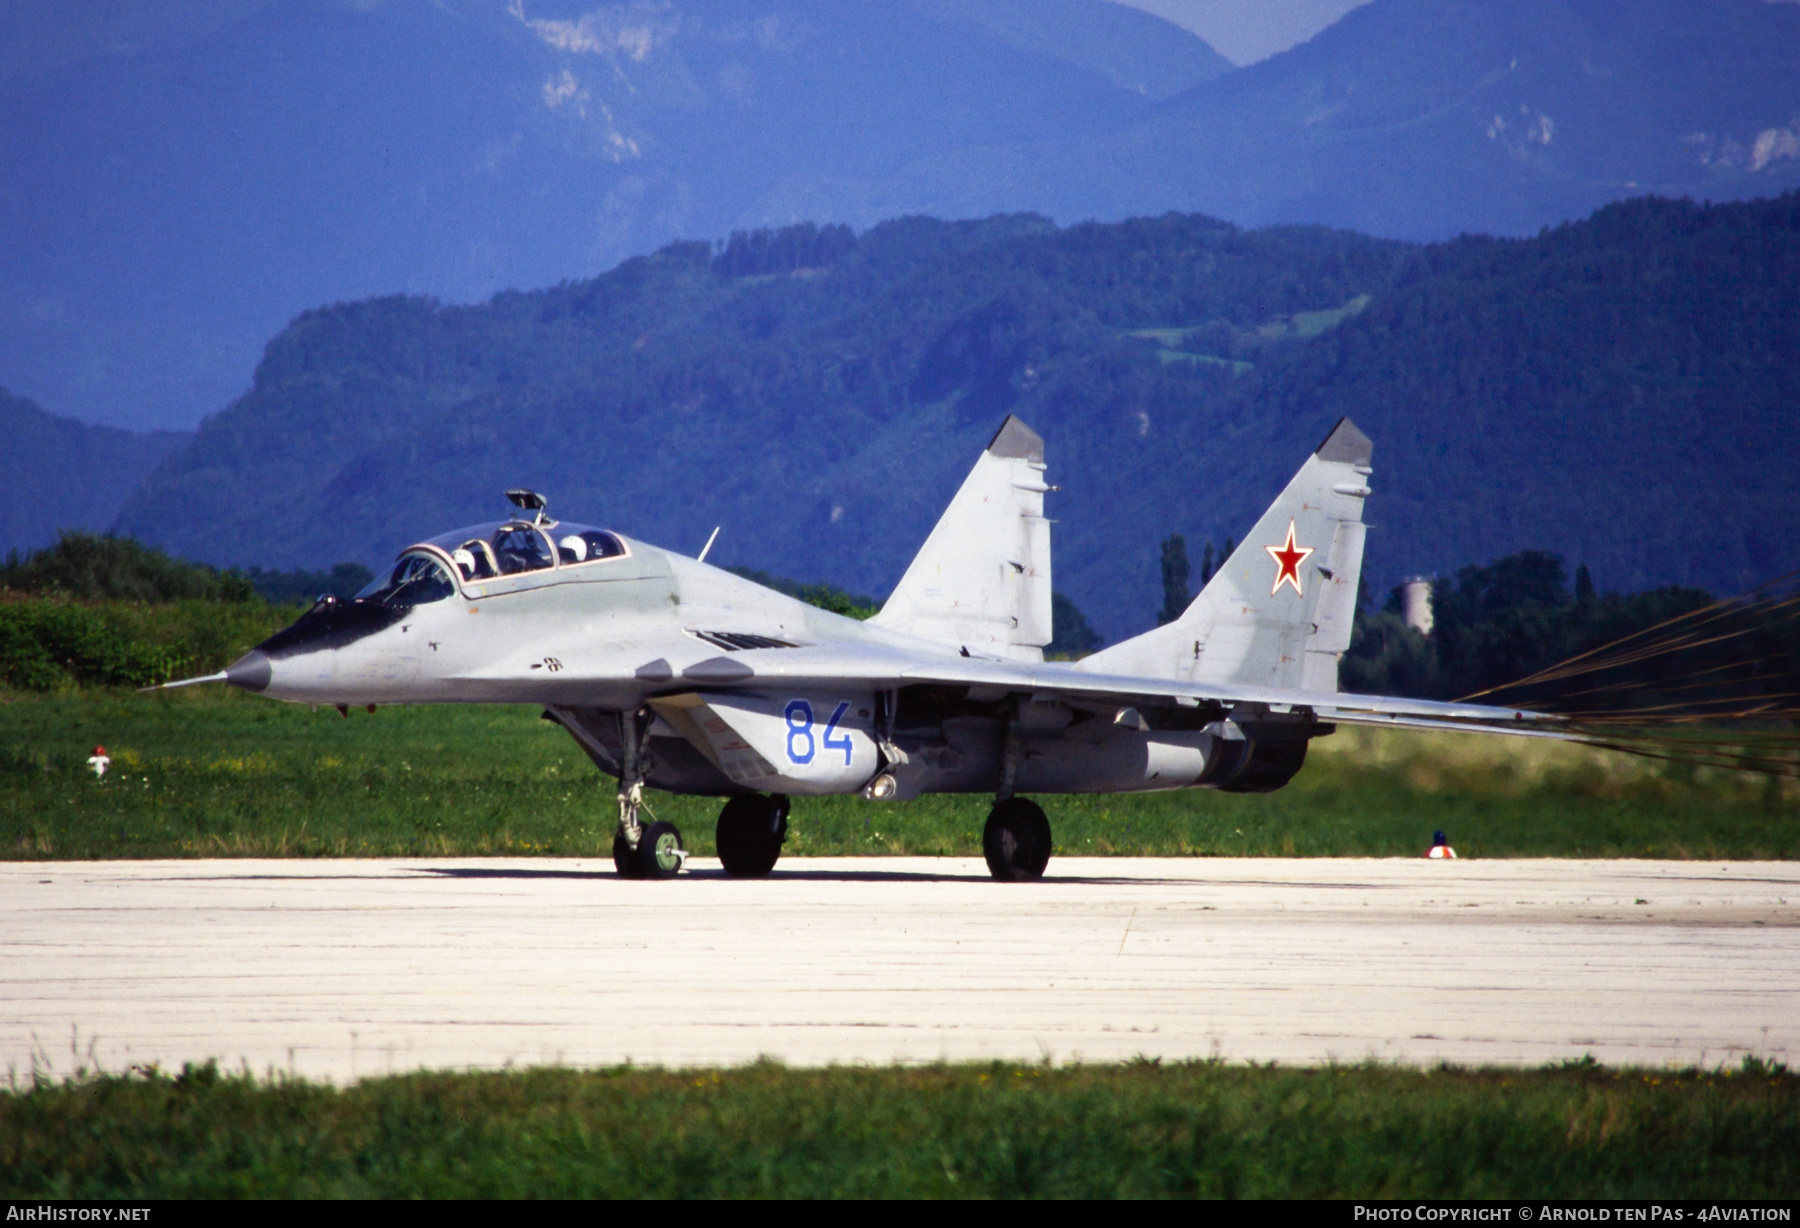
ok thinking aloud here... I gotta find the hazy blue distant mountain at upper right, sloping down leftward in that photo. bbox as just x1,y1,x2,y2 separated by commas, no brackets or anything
871,0,1800,239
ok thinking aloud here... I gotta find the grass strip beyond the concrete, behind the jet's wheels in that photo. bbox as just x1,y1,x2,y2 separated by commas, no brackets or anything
0,688,1800,859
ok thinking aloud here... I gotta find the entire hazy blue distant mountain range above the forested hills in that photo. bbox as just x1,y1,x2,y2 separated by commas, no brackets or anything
0,0,1800,429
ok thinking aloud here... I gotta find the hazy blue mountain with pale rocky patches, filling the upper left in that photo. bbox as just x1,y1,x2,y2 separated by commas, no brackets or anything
0,0,1231,425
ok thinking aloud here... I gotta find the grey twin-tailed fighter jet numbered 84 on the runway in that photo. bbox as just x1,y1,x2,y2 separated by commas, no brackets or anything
173,418,1553,880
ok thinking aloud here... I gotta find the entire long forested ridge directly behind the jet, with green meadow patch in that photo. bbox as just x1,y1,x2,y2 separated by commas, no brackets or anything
119,194,1800,639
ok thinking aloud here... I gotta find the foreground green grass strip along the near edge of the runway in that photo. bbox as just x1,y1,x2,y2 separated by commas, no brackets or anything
0,1061,1800,1199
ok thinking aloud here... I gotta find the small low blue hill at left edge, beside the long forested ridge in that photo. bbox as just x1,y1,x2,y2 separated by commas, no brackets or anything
0,387,193,555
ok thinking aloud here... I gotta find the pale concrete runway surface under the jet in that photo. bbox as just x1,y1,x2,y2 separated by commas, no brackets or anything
0,857,1800,1080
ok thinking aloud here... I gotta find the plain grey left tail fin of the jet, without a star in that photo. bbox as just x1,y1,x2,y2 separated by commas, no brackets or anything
869,416,1051,661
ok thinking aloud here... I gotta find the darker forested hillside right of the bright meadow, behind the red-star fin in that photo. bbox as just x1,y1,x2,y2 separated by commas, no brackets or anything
1202,193,1800,594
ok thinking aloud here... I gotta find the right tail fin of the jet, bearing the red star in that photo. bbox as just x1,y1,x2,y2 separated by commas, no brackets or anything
1078,418,1373,693
